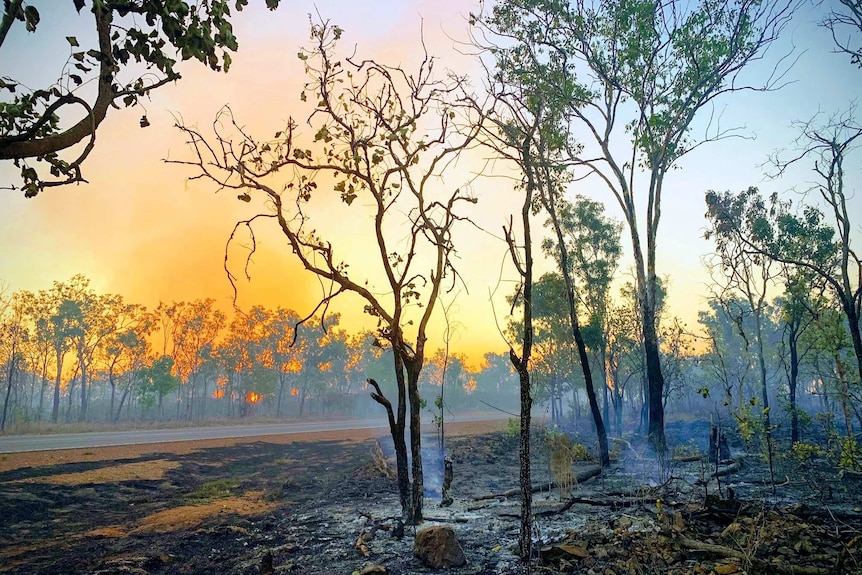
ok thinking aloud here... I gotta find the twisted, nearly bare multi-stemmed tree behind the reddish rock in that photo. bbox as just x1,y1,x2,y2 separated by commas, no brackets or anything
174,18,478,523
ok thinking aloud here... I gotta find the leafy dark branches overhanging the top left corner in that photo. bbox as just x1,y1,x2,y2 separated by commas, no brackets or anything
0,0,279,198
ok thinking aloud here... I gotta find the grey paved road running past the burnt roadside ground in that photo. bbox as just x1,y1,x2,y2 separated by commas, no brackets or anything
0,414,500,453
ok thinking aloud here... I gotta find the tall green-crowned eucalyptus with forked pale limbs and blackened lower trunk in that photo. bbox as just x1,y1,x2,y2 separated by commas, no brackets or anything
474,0,793,452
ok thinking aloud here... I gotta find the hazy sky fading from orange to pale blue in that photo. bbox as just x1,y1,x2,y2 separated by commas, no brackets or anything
0,0,862,366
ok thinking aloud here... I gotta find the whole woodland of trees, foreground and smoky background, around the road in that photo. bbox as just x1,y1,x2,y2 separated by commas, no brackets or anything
0,0,862,573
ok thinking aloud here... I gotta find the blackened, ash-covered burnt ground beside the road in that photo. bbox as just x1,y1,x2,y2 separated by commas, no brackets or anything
0,432,862,575
